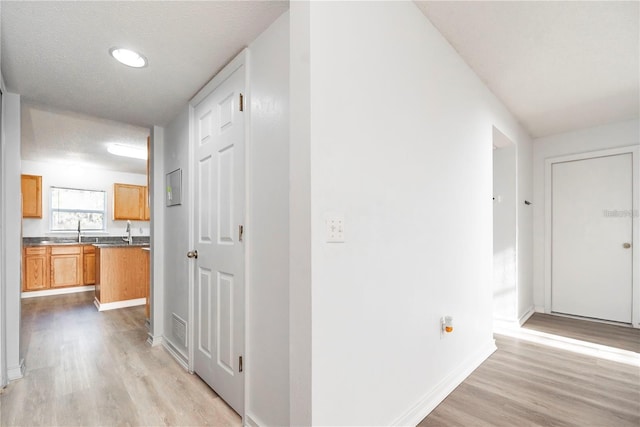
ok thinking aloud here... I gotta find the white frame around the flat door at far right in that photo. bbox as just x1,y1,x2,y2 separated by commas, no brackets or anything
544,145,640,328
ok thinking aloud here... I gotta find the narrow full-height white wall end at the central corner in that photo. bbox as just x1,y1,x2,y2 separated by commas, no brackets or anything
289,1,312,426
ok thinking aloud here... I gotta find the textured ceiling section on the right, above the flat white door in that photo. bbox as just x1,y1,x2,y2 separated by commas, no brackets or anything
416,1,640,137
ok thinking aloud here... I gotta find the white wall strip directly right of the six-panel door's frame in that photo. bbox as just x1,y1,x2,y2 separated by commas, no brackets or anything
245,12,290,426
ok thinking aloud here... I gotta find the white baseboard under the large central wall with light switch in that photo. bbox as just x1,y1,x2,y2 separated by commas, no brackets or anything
391,340,497,426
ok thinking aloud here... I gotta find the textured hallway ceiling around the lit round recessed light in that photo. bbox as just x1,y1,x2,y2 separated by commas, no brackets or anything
0,0,288,127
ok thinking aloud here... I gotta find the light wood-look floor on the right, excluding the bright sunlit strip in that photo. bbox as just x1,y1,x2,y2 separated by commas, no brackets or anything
419,314,640,427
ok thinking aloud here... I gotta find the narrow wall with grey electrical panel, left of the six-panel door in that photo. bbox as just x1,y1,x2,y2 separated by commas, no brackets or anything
162,106,192,360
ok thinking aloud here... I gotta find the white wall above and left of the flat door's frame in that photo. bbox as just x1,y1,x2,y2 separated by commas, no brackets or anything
533,120,640,311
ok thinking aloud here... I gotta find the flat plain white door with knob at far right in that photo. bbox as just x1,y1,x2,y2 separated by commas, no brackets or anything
551,153,633,323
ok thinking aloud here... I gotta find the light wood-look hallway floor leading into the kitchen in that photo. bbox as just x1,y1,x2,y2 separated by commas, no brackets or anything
0,292,241,427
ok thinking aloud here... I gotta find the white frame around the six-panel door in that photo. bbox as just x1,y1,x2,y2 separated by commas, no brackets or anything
183,48,251,420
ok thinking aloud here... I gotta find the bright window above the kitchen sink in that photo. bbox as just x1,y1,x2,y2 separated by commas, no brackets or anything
51,187,107,231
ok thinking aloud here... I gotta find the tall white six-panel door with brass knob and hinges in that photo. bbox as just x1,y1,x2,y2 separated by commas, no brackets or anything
193,66,245,414
